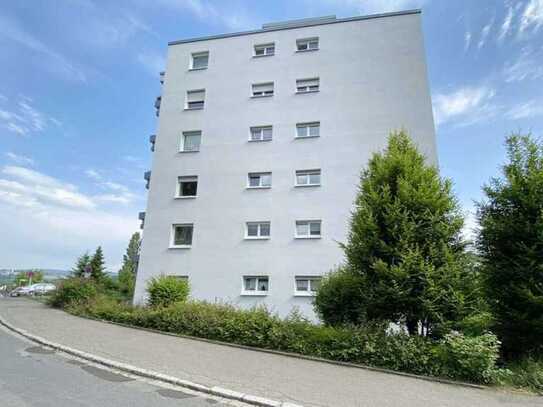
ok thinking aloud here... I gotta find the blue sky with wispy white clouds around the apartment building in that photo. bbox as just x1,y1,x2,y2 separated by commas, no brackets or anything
0,0,543,270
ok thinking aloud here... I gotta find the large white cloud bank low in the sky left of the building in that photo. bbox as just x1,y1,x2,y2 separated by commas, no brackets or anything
0,166,138,268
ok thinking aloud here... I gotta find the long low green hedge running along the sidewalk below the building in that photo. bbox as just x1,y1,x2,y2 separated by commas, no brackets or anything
70,296,506,383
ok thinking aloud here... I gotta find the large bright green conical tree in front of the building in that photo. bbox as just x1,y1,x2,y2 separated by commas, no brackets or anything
343,131,480,335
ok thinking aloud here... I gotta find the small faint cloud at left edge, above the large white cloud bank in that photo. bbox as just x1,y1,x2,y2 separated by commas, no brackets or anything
0,96,62,136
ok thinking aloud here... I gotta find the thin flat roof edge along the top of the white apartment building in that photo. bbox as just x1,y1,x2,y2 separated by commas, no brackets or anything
168,9,421,45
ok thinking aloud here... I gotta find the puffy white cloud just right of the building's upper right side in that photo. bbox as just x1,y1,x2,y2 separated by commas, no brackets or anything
433,86,496,125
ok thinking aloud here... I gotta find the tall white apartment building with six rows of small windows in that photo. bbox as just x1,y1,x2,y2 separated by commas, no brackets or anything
134,10,437,318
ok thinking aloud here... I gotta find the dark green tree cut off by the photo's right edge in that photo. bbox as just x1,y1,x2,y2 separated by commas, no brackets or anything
477,135,543,354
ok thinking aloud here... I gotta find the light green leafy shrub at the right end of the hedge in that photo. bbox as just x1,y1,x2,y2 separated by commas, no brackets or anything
437,332,500,383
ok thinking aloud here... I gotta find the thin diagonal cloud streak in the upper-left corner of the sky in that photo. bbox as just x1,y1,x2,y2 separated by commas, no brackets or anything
0,15,87,82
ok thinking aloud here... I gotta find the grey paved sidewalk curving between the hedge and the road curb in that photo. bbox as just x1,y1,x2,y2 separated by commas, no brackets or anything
0,298,543,407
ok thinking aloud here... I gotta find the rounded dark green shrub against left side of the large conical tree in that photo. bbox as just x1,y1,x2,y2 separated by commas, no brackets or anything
314,267,365,326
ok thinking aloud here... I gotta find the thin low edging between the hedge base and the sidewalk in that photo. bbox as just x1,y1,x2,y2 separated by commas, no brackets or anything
74,310,491,392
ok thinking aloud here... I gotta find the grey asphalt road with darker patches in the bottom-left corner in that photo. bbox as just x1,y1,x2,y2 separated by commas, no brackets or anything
0,328,239,407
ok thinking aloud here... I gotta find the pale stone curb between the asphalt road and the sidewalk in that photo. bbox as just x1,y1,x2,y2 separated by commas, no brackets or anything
0,316,303,407
